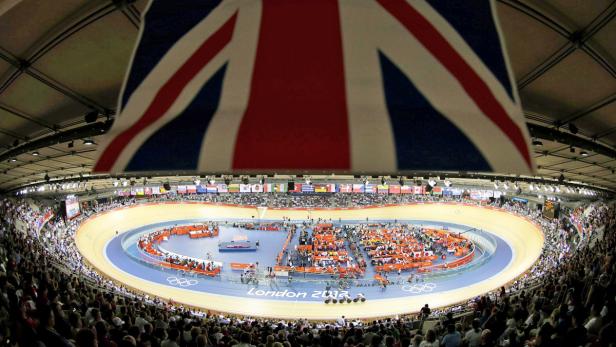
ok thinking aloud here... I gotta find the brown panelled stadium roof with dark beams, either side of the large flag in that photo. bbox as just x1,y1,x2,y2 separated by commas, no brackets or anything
0,0,616,190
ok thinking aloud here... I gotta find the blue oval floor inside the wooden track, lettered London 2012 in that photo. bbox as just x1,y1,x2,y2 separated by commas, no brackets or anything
105,219,513,301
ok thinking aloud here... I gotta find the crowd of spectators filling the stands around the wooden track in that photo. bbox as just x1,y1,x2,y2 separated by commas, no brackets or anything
0,194,616,347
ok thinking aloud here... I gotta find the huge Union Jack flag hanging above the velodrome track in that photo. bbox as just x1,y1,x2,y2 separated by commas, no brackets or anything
94,0,534,173
